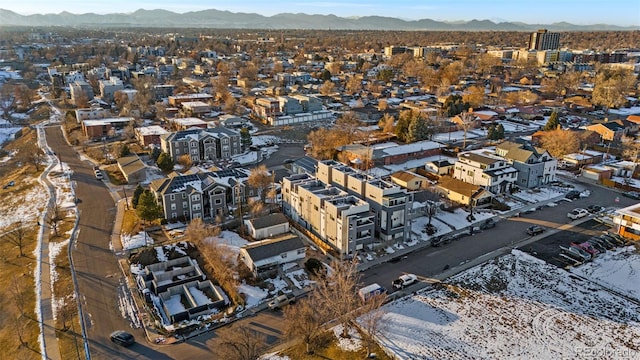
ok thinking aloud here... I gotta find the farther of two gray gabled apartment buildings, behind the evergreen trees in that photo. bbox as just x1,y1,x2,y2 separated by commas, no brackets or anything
160,127,243,162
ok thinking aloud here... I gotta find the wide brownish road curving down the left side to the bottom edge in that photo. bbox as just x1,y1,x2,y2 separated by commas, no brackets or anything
45,126,211,360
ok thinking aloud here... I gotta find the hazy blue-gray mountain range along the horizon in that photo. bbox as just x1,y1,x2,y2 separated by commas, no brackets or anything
0,9,640,31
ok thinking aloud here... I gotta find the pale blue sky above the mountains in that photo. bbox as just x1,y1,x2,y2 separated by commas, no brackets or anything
0,0,640,26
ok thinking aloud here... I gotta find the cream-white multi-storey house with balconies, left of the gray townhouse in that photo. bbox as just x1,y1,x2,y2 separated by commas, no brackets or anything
453,152,518,194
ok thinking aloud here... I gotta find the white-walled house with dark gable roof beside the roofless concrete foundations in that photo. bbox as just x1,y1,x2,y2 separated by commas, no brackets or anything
239,235,307,277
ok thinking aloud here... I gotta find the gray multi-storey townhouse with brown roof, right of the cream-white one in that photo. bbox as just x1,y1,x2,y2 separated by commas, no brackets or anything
496,141,558,188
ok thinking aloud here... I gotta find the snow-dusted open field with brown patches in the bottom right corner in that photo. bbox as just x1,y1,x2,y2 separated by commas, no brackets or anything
378,250,640,359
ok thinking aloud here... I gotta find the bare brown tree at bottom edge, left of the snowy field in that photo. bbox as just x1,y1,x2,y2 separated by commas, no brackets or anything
215,326,266,360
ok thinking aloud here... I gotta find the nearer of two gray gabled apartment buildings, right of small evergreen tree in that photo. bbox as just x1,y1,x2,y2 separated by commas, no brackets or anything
150,173,230,220
